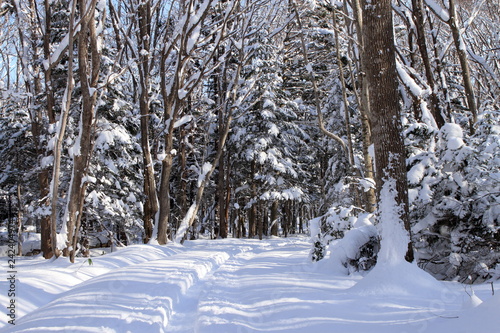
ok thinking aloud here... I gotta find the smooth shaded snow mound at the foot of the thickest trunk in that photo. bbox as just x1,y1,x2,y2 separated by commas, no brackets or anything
350,261,448,298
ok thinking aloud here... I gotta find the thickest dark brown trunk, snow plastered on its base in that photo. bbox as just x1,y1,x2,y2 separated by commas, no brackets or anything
362,0,413,262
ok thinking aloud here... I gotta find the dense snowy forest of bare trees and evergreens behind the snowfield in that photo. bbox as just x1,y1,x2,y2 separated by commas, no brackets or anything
0,0,500,283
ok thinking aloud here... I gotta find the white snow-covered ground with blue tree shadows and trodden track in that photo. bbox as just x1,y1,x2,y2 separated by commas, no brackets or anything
0,237,500,333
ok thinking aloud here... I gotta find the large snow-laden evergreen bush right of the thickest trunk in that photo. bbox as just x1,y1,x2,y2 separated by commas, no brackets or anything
409,111,500,282
